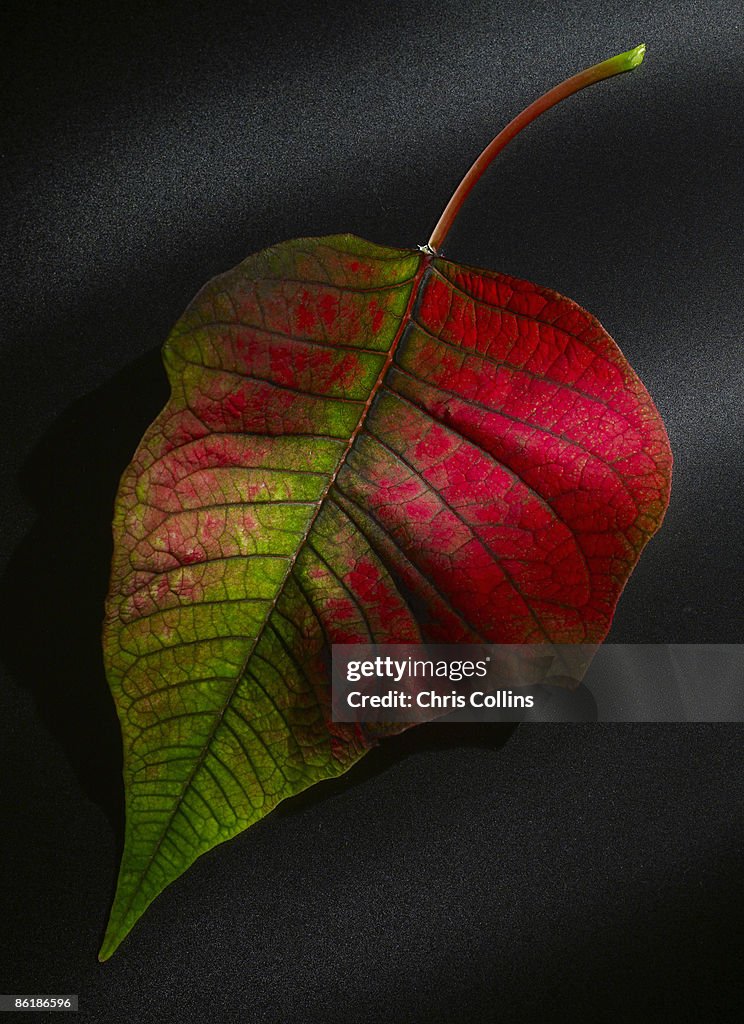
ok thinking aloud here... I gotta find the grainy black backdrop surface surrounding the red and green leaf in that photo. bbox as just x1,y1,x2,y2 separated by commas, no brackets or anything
0,0,744,1024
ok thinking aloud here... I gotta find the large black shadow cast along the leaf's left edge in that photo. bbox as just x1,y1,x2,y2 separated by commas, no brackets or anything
0,350,168,839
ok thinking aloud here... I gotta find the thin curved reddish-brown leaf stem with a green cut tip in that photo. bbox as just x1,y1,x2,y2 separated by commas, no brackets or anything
423,43,646,255
